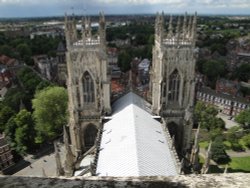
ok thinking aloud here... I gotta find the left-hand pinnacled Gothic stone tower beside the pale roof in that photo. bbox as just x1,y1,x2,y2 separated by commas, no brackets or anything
65,14,111,158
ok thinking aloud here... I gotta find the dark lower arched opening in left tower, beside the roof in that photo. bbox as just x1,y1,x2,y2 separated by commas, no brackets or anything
84,124,97,150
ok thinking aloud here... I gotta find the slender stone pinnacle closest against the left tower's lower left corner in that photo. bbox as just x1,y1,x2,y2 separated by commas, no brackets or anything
63,126,74,176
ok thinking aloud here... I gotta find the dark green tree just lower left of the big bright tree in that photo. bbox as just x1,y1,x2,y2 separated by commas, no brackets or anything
14,109,35,155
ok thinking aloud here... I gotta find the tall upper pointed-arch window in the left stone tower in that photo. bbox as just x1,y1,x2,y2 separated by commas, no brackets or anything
82,72,95,103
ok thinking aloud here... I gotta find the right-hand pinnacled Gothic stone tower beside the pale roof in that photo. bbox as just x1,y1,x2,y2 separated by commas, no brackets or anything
151,13,196,155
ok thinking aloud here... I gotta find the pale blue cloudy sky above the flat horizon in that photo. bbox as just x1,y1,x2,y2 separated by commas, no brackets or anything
0,0,250,18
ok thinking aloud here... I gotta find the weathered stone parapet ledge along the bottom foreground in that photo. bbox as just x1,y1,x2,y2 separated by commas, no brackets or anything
0,173,250,188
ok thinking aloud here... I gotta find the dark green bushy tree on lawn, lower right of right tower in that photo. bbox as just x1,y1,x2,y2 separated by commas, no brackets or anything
211,137,230,164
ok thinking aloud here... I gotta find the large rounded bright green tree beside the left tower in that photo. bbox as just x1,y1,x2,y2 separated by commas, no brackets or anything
32,87,68,143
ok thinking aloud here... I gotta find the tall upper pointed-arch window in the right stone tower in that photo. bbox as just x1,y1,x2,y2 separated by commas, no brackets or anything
168,70,180,102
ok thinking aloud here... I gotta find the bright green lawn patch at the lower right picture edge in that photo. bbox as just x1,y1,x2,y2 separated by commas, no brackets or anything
228,156,250,172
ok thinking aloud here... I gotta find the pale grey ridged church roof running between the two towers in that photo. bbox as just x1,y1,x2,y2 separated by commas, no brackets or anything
96,93,178,177
